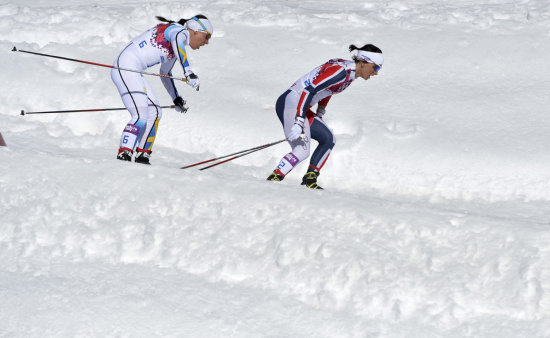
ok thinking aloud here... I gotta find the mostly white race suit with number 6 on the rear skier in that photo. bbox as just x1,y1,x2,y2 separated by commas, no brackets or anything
111,23,193,153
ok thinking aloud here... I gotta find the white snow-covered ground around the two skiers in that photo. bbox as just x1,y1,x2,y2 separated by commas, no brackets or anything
0,0,550,337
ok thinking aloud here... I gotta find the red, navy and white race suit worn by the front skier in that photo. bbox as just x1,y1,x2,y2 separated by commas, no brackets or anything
275,59,355,175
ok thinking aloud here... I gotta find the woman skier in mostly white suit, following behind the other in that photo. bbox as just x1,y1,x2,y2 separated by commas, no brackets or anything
111,14,213,164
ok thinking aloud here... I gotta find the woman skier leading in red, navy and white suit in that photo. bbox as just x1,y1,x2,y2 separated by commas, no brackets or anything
267,44,384,189
